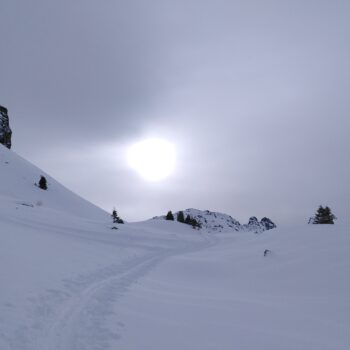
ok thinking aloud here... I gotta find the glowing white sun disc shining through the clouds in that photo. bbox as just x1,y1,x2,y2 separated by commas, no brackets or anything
127,139,176,181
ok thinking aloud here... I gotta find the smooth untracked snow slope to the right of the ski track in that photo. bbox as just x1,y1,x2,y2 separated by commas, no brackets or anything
118,225,350,350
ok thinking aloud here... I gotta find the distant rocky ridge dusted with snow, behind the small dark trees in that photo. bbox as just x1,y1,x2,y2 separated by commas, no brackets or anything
153,208,276,233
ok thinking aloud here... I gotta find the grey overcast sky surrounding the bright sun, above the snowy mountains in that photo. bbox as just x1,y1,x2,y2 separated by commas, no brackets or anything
0,0,350,224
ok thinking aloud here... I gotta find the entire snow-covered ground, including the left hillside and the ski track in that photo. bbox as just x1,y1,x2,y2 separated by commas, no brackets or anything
0,146,350,350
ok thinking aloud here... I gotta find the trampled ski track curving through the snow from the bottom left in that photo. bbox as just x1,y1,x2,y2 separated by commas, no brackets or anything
10,227,216,350
